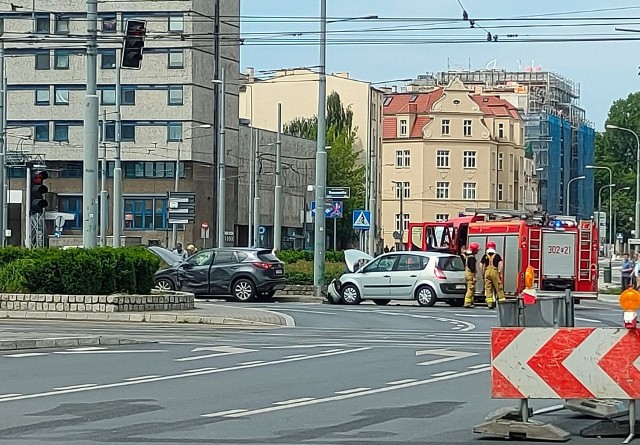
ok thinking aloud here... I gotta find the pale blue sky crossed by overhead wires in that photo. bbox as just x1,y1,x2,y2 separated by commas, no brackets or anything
240,0,640,131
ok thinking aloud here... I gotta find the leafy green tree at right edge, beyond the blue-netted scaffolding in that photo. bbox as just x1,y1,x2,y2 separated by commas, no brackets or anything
595,92,640,238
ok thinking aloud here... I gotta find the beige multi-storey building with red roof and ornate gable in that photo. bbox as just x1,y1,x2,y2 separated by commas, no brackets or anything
381,78,528,246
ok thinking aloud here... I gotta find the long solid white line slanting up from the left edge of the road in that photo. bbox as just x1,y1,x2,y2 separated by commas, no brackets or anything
0,347,371,403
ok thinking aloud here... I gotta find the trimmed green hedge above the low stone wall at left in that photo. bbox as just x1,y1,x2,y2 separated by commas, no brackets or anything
0,247,160,295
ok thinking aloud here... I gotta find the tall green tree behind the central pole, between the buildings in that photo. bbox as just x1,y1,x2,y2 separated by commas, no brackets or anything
284,91,365,248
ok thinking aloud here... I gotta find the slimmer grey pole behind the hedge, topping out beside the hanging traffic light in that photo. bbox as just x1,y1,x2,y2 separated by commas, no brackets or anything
112,47,124,247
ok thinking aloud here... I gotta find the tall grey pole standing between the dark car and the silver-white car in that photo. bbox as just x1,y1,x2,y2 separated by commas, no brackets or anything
313,0,327,297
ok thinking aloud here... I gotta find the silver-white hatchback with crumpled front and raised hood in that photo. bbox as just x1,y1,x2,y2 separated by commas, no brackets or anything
327,250,467,307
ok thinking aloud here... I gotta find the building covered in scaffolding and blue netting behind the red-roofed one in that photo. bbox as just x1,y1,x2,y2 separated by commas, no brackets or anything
406,68,595,218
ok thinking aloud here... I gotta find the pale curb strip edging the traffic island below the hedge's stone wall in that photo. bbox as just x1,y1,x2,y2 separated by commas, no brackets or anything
0,311,287,326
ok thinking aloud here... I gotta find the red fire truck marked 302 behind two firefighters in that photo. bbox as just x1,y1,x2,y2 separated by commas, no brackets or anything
407,209,599,299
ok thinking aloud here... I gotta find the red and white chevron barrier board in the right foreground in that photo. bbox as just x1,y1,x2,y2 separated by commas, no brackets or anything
491,328,640,400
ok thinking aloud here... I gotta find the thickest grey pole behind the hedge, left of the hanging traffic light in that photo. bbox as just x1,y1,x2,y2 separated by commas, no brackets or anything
82,0,99,248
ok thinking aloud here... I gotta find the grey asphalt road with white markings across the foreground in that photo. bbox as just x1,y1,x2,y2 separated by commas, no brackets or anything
0,303,632,445
